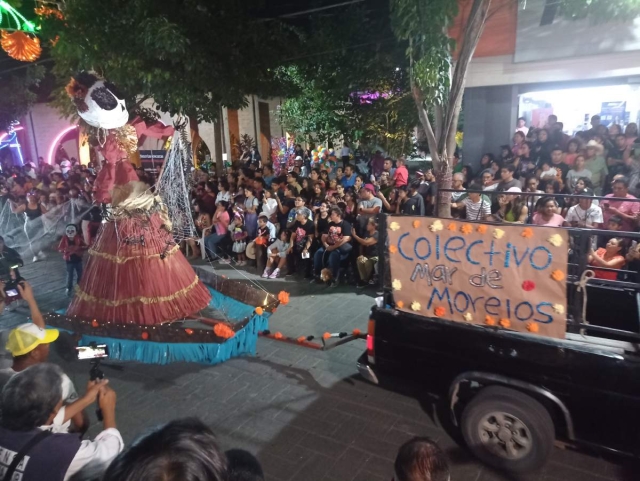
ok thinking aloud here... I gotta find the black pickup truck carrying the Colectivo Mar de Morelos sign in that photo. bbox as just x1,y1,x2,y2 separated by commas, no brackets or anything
358,217,640,473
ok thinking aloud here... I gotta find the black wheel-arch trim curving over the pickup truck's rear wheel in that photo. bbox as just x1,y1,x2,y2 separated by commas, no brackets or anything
449,371,575,441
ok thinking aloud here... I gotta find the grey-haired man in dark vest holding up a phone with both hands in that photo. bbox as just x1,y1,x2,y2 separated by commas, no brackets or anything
0,363,124,481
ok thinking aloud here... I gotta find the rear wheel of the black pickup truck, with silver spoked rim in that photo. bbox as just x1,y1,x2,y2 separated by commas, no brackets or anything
460,386,555,473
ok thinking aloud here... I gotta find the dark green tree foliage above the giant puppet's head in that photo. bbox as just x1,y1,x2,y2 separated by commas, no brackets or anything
42,0,295,121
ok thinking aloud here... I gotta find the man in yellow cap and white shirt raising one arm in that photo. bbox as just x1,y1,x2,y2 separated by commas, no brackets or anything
0,281,95,433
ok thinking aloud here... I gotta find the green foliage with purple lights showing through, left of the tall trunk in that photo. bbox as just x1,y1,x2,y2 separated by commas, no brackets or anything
279,1,418,153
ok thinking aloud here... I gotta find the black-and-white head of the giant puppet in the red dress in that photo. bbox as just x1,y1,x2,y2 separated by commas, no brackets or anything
66,72,129,129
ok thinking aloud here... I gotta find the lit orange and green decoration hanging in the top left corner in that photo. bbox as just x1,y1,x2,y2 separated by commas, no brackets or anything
0,0,42,62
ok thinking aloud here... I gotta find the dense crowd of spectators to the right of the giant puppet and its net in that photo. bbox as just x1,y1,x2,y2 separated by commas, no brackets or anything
191,116,640,287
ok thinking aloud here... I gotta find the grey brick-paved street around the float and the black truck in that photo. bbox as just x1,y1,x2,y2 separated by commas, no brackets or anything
0,259,640,481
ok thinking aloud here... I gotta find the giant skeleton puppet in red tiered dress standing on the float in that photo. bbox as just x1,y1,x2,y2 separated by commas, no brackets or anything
62,72,211,325
